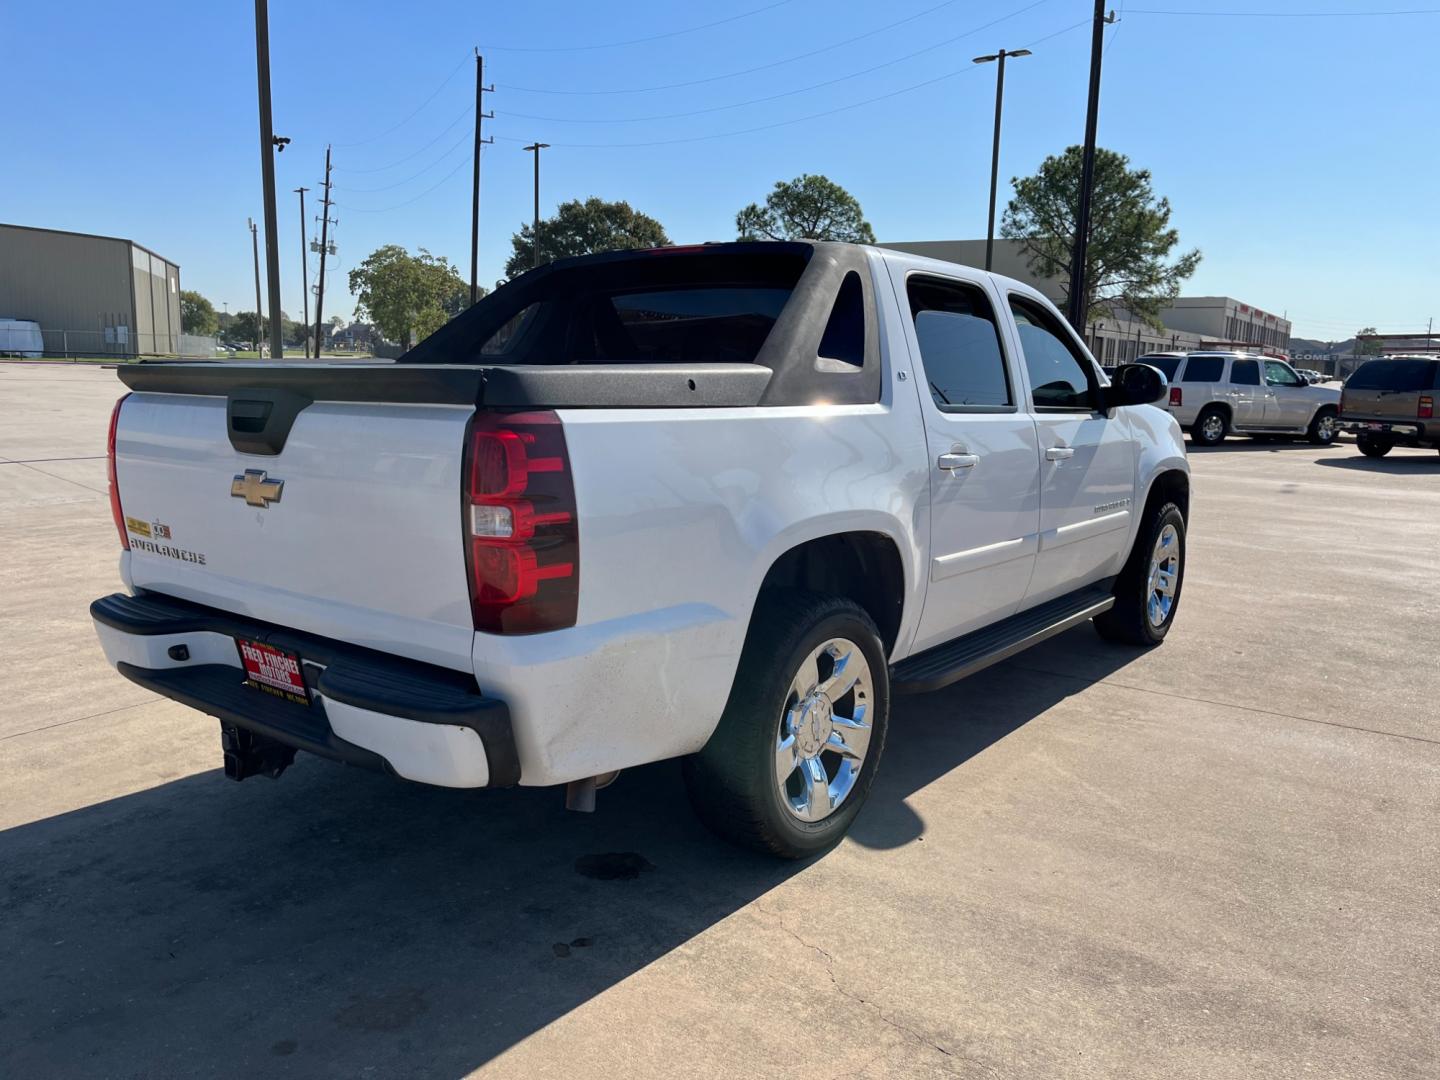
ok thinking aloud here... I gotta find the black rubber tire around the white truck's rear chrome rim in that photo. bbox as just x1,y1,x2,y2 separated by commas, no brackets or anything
683,592,890,858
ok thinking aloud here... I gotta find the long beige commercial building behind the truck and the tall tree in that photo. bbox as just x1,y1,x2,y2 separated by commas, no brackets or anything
881,239,1290,367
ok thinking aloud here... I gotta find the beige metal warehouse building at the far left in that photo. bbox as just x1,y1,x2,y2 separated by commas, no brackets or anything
0,225,180,357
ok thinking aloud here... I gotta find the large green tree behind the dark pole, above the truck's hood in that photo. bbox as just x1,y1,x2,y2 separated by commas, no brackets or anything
999,147,1201,325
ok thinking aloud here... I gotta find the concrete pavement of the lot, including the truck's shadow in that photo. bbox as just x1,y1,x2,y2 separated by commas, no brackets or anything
0,364,1440,1079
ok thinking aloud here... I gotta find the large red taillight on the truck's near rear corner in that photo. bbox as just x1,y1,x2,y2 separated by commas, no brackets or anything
464,412,580,634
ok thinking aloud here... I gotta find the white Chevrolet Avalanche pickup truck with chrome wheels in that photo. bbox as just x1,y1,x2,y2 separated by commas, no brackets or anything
91,243,1189,857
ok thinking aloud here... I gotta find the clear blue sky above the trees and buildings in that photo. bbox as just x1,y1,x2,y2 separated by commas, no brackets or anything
0,0,1440,338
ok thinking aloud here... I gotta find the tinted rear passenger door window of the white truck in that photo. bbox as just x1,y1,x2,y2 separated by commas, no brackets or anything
909,276,1015,412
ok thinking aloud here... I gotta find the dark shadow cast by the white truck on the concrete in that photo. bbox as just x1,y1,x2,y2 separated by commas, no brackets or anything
0,628,1136,1077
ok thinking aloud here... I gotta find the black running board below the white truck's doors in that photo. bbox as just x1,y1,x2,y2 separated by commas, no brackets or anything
890,582,1115,694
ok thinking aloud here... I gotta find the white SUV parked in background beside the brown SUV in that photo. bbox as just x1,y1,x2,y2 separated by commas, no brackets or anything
1169,353,1339,446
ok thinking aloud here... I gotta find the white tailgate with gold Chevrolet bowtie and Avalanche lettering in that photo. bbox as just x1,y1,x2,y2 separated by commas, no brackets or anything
115,379,474,671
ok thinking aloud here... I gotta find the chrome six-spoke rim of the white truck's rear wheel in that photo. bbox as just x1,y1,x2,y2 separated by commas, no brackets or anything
775,638,874,822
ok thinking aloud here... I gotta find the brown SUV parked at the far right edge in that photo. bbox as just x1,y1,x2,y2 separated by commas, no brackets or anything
1339,356,1440,458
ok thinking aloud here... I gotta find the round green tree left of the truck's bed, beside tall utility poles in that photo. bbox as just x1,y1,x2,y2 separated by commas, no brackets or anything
350,243,469,348
